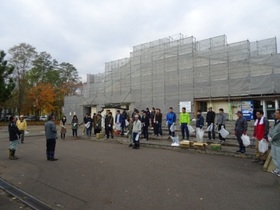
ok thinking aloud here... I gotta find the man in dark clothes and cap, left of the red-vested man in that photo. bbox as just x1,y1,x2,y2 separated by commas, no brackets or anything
234,111,248,153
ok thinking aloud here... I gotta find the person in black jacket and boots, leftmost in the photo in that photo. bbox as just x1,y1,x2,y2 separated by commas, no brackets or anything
8,115,21,160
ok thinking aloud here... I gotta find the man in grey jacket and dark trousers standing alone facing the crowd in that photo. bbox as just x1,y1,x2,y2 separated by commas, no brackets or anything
45,115,58,161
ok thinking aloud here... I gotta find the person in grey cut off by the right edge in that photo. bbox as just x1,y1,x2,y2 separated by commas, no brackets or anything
268,109,280,177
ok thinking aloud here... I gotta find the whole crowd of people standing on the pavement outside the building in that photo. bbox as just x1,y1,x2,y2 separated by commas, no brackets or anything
5,107,280,177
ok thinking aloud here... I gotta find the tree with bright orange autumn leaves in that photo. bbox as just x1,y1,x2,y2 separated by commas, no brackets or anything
27,82,55,117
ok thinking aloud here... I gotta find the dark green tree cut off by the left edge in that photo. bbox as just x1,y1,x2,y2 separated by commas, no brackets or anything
0,51,15,106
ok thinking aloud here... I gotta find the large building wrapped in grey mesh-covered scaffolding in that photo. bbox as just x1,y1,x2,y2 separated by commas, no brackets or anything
64,35,280,121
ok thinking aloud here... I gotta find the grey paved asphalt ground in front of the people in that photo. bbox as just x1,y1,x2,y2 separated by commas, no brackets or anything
0,127,280,210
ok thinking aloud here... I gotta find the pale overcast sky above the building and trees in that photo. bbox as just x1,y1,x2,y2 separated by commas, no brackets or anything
0,0,280,81
